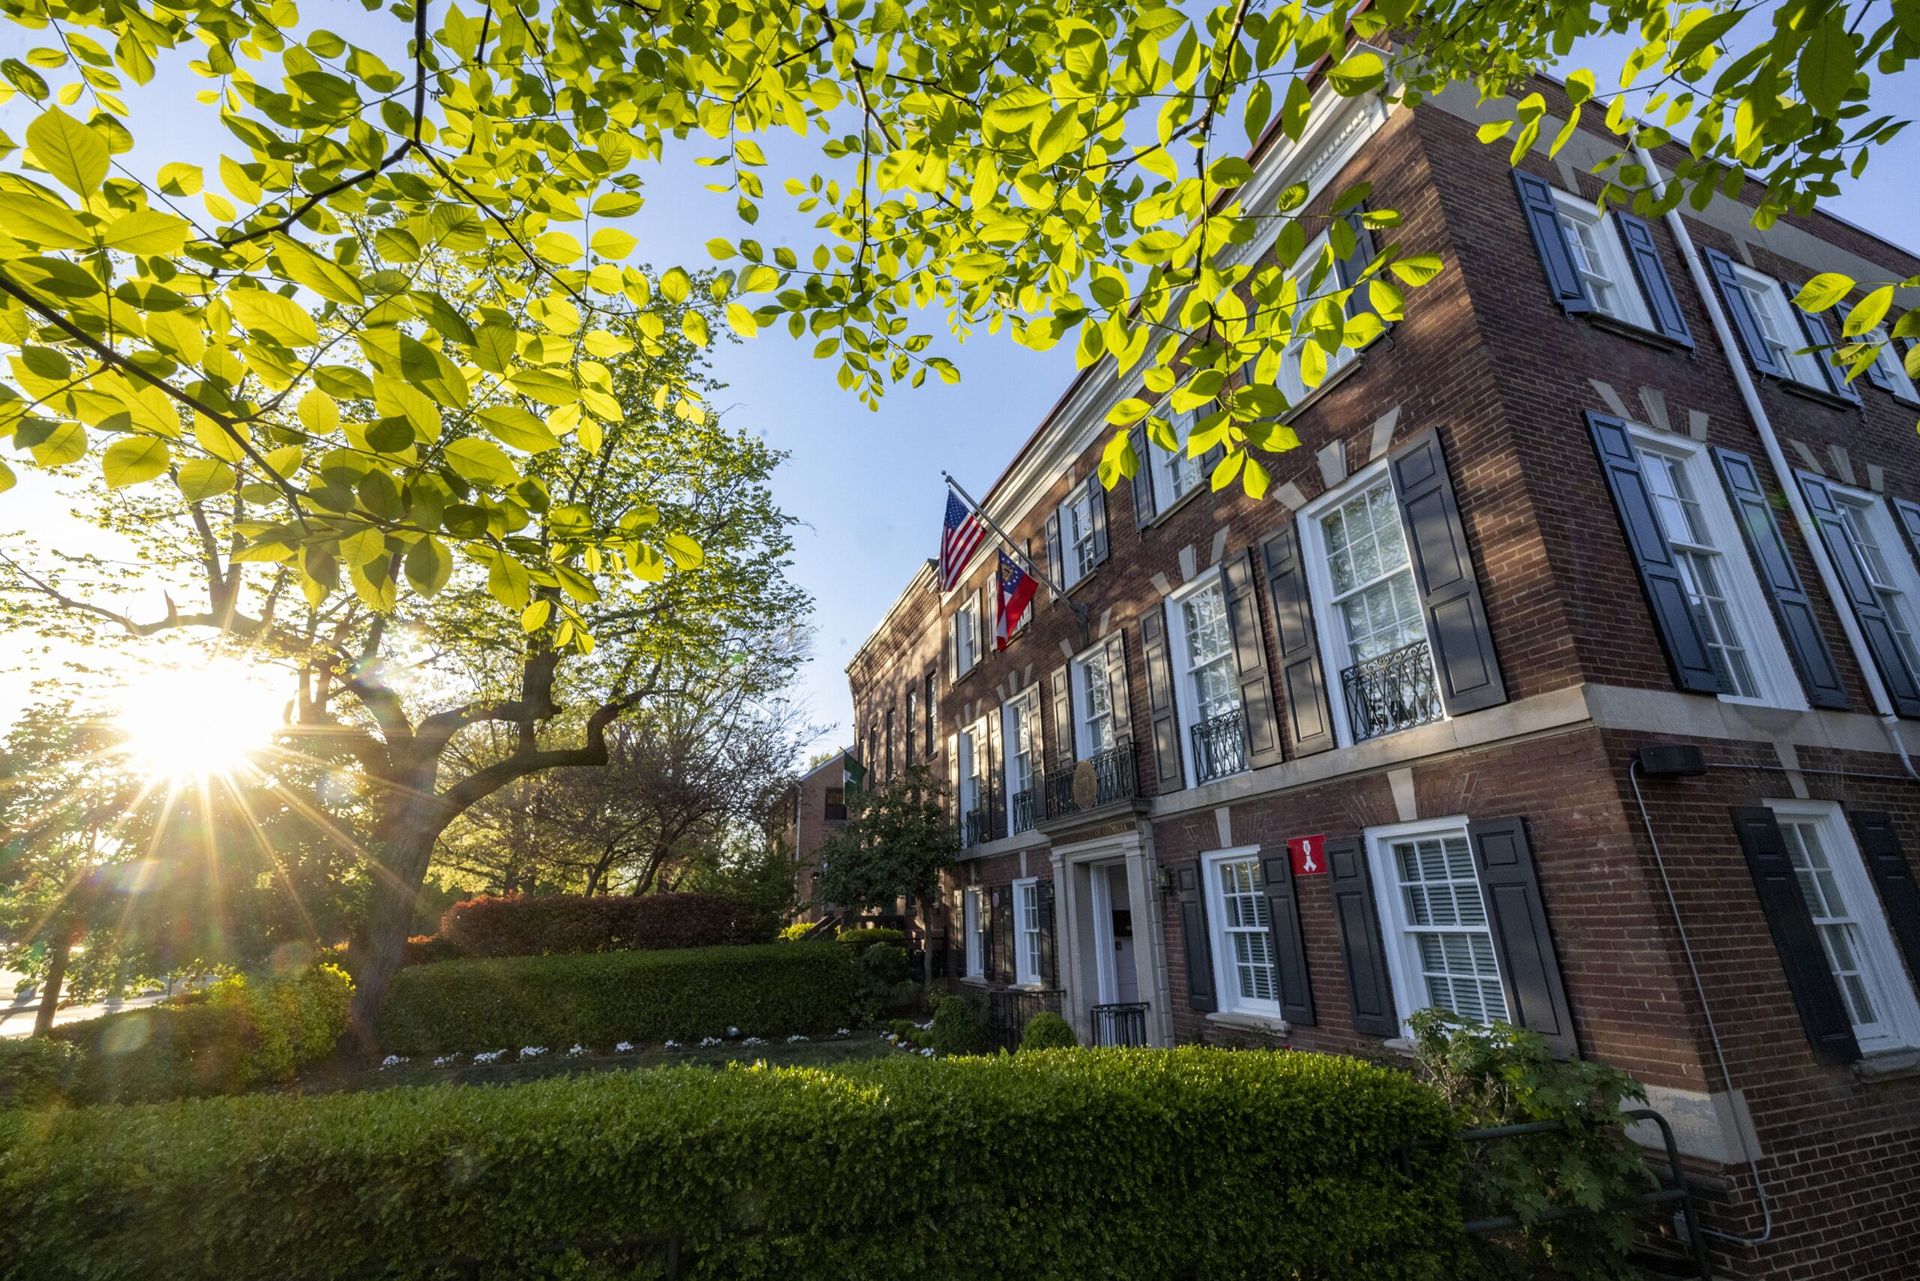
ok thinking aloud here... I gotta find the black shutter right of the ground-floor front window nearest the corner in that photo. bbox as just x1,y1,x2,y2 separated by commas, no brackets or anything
1467,818,1580,1058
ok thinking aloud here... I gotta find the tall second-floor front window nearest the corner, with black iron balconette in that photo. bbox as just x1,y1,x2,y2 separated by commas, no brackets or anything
1302,465,1446,741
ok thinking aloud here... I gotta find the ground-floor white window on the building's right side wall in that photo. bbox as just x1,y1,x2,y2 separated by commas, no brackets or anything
1766,801,1920,1054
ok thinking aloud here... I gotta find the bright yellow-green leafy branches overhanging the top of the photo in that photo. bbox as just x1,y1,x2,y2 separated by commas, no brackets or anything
0,0,1920,647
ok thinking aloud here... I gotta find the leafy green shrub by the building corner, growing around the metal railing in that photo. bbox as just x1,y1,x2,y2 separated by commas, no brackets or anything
1411,1010,1653,1279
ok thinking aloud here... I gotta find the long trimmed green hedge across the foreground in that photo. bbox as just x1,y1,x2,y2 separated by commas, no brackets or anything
0,1049,1461,1281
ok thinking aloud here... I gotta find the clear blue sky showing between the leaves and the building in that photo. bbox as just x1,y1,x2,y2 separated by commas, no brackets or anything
0,19,1920,760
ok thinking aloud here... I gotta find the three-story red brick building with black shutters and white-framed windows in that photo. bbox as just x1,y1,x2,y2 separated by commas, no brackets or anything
849,67,1920,1279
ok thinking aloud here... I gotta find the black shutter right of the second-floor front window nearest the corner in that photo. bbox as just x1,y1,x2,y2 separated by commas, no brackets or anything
1388,432,1507,716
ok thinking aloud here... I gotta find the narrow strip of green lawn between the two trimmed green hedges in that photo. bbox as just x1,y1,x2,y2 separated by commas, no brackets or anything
288,1031,900,1095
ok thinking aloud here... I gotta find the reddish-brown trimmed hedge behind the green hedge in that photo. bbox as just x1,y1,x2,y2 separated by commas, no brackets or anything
438,893,772,956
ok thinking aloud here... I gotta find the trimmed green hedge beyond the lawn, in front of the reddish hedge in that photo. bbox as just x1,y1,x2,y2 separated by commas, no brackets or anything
380,943,852,1054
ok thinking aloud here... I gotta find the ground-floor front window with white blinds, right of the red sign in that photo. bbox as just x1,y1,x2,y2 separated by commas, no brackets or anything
1367,818,1509,1024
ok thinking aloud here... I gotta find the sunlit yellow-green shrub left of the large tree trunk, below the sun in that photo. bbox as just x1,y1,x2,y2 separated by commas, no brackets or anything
54,964,353,1102
